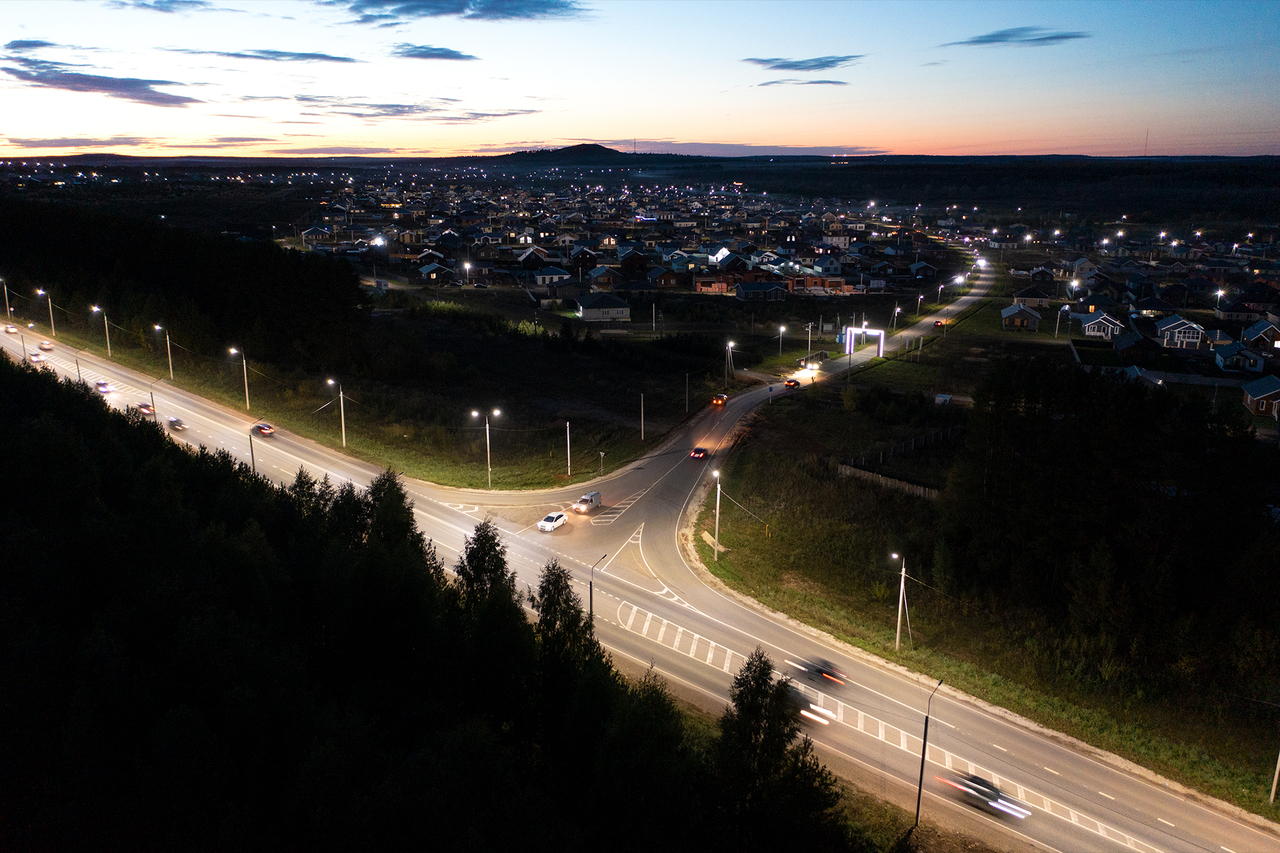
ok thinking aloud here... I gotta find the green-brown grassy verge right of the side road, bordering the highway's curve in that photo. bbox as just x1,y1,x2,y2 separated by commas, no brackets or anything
696,302,1280,820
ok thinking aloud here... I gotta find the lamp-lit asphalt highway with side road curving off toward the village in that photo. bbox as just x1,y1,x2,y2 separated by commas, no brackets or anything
0,262,1280,853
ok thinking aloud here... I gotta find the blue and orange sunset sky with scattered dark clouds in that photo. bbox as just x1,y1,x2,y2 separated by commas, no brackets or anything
0,0,1280,159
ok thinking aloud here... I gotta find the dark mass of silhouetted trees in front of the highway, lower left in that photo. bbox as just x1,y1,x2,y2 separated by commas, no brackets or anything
0,361,870,852
